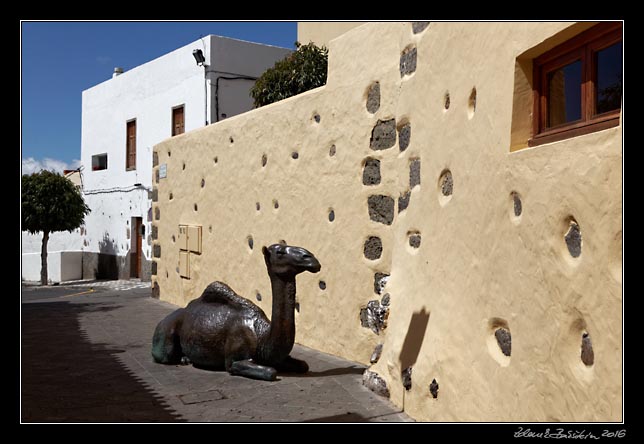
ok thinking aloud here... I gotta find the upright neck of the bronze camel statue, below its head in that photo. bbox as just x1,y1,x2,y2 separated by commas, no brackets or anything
264,274,295,362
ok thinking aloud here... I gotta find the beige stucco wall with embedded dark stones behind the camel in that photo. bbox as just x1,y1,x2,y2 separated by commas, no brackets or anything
153,22,623,421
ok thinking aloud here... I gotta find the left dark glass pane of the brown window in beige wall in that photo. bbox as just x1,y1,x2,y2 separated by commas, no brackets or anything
548,60,581,128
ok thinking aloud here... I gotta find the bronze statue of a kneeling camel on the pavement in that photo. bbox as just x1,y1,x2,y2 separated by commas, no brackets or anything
152,244,321,381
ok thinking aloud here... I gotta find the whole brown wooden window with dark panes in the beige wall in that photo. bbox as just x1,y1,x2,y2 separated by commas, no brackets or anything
529,22,623,146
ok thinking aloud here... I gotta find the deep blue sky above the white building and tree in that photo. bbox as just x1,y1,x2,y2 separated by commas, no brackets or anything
21,22,297,173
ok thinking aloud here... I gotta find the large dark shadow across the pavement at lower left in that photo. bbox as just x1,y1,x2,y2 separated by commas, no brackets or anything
21,302,182,422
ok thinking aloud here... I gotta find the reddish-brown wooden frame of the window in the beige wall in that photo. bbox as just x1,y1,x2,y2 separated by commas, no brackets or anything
528,22,623,146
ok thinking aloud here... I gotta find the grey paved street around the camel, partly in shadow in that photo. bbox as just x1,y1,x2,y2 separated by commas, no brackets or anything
21,285,412,422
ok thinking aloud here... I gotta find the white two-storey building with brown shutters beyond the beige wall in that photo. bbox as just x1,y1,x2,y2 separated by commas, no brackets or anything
22,35,290,281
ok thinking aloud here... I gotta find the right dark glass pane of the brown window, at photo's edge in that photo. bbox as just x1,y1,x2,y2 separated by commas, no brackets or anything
596,42,622,114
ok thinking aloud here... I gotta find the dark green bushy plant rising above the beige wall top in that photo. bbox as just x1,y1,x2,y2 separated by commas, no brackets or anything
250,42,329,108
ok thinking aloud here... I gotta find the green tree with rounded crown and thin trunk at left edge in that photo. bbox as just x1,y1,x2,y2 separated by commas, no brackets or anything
22,170,90,285
